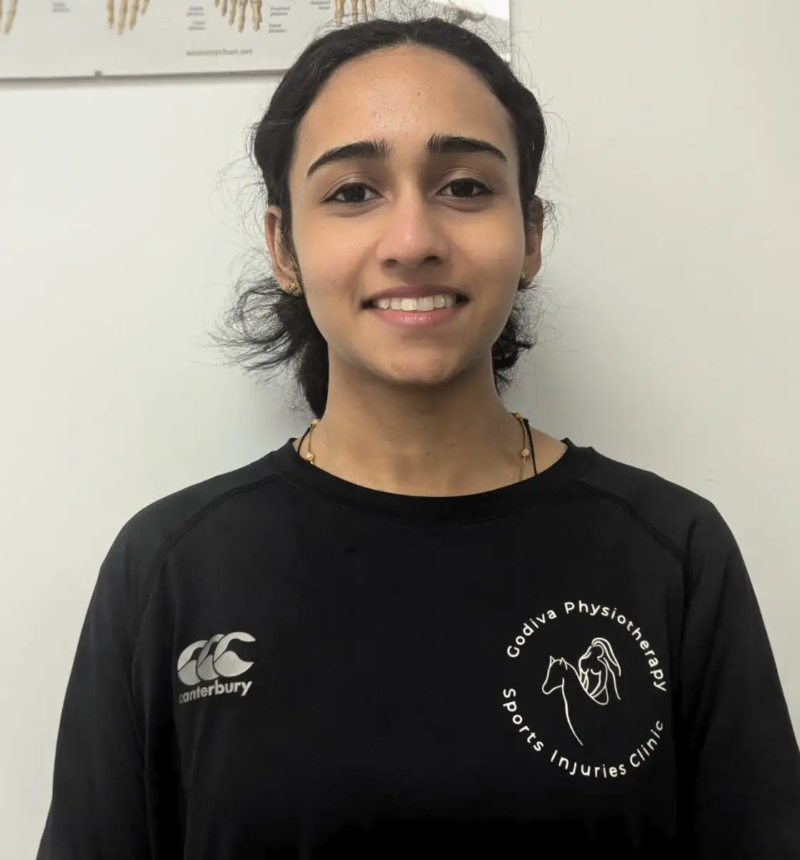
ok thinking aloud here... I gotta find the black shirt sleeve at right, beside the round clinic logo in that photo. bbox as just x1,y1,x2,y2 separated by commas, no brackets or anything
678,505,800,860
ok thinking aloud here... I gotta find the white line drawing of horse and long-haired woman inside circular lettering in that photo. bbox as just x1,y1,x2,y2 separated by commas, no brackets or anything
542,637,622,746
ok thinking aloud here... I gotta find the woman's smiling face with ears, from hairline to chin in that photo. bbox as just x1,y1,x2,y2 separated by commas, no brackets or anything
267,42,541,396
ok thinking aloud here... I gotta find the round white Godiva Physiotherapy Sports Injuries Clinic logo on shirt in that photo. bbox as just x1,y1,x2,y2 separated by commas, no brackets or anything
501,600,669,779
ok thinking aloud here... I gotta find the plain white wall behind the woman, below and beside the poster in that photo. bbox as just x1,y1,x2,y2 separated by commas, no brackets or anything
0,0,800,858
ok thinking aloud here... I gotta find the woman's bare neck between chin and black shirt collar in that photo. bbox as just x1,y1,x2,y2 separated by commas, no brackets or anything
304,363,532,496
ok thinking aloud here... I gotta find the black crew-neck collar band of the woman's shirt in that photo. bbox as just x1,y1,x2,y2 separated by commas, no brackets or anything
272,437,596,523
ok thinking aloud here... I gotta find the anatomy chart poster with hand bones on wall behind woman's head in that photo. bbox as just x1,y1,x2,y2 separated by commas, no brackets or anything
0,0,510,78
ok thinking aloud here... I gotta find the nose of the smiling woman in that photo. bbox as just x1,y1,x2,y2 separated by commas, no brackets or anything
378,188,452,269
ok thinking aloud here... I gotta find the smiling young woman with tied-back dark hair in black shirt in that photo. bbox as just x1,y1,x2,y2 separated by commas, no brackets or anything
39,13,800,860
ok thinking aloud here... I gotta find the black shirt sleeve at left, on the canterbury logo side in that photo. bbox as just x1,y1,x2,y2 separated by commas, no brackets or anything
37,524,151,860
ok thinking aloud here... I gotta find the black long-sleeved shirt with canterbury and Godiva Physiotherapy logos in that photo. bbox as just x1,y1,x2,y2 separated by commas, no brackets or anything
39,440,800,860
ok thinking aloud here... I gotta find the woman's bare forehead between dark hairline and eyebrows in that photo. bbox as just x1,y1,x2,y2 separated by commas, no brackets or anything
295,46,515,170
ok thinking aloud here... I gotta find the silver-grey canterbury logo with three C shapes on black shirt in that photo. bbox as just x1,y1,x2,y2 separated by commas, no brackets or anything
178,632,256,704
